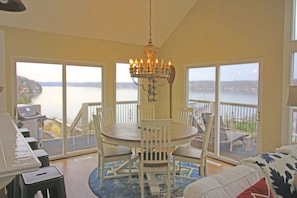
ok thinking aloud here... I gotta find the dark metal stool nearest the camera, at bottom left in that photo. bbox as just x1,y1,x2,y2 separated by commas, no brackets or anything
20,166,66,198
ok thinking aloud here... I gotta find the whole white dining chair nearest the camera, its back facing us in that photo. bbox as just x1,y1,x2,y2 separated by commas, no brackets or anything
139,119,172,198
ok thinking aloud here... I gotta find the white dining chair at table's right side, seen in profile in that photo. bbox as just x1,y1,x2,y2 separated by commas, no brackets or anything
172,115,214,182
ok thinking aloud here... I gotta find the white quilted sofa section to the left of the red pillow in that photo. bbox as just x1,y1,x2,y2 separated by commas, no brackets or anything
184,165,261,198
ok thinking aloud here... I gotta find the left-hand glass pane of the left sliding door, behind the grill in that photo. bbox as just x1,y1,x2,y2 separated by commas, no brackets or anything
16,62,63,156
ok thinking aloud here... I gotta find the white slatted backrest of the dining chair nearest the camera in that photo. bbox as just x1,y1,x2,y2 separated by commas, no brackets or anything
140,119,172,164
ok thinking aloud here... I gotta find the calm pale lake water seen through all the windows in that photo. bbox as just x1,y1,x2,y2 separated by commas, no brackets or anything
32,86,258,123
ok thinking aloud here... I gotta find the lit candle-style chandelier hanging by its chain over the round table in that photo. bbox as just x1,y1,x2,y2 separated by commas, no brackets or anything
129,0,175,102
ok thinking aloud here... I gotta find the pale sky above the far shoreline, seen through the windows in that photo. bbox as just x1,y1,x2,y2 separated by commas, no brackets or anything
17,62,259,82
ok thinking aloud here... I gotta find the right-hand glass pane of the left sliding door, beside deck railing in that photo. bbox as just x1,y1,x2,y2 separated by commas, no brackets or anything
66,65,102,152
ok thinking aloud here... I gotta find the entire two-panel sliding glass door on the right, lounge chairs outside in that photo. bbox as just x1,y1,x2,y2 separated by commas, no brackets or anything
187,62,259,161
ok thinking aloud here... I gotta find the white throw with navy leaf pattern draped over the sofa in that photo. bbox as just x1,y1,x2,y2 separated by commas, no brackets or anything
240,153,297,198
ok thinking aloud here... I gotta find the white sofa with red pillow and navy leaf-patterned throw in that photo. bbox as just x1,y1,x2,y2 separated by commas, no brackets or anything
183,145,297,198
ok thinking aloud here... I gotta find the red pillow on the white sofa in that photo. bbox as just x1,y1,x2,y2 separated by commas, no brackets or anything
237,177,274,198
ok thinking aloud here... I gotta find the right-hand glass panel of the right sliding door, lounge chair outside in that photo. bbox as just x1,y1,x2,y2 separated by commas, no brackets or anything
218,63,259,161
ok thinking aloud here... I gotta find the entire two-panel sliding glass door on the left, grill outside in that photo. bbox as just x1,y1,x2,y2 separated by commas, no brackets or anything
16,62,102,157
